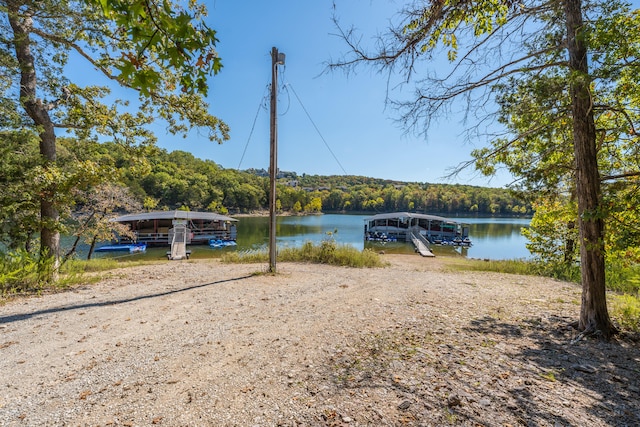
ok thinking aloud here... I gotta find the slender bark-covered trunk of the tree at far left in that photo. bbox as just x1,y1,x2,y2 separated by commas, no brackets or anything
7,1,60,281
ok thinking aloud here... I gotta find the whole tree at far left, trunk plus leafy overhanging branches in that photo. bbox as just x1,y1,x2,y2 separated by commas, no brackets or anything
0,0,228,279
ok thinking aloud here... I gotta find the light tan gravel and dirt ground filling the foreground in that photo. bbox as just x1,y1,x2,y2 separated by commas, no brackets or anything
0,255,640,426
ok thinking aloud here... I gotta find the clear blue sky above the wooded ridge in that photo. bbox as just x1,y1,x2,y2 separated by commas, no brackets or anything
158,0,510,187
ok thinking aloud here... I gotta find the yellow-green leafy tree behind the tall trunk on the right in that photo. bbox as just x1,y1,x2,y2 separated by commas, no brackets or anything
475,3,640,328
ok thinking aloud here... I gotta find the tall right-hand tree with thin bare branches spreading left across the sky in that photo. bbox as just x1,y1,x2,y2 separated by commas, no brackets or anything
332,0,637,339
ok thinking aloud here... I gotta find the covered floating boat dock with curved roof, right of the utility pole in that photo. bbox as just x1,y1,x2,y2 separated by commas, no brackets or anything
364,212,471,245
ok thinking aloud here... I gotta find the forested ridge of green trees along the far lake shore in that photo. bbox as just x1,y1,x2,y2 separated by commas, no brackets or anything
96,144,533,215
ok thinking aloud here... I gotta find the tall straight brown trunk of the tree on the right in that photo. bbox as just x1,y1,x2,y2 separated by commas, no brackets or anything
564,0,616,339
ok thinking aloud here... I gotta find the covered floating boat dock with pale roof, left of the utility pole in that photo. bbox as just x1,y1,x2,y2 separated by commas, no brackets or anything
111,210,238,246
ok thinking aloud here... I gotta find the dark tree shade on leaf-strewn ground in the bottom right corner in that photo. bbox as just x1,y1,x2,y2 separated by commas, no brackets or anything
468,316,640,426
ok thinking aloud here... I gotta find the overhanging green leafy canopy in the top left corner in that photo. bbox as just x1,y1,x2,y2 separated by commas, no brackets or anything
0,0,229,145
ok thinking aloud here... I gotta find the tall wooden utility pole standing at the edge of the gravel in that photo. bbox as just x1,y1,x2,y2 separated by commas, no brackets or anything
269,47,284,273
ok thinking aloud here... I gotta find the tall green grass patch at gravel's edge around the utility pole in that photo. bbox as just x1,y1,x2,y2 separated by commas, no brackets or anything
221,240,388,268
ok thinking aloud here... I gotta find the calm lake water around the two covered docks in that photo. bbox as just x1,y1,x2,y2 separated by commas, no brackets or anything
86,214,531,259
